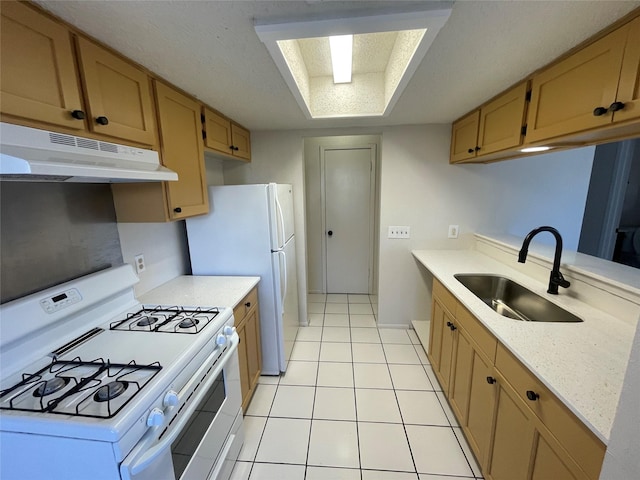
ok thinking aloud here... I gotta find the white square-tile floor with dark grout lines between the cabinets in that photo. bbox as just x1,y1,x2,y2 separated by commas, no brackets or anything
231,295,481,480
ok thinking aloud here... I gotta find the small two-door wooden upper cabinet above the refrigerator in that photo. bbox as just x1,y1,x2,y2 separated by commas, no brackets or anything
203,108,251,161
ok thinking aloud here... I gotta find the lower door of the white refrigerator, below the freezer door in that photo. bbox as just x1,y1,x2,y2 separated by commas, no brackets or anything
272,237,300,372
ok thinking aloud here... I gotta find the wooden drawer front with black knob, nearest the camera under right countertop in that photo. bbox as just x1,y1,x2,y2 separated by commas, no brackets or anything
496,344,605,479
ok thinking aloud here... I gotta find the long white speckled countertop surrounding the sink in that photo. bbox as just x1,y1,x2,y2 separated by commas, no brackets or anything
412,250,635,444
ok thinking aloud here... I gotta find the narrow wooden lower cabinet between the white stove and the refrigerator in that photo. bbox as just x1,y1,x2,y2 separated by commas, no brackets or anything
233,287,262,412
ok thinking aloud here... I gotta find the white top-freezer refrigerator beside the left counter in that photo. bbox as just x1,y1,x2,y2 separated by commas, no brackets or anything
186,183,300,375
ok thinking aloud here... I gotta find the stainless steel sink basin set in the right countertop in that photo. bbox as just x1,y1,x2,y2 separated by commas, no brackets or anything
454,274,582,322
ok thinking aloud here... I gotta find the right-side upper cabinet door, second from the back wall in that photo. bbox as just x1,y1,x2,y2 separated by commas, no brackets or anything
478,82,527,156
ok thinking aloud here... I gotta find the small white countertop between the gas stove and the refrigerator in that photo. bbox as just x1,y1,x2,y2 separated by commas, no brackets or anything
138,275,260,308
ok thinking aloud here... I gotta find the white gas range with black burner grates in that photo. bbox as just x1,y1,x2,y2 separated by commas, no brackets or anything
0,265,243,480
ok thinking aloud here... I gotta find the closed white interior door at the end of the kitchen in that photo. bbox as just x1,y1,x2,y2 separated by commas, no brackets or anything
323,148,374,294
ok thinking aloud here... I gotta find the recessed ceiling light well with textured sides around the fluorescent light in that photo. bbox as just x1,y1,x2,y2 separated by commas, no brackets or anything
255,9,451,119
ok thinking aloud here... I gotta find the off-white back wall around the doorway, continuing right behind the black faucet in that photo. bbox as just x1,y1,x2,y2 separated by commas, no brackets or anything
224,125,593,326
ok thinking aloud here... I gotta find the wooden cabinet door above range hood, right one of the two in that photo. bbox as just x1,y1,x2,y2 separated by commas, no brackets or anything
78,38,157,145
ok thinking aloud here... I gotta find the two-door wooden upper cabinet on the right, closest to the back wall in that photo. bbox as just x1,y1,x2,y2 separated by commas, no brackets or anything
450,82,528,163
